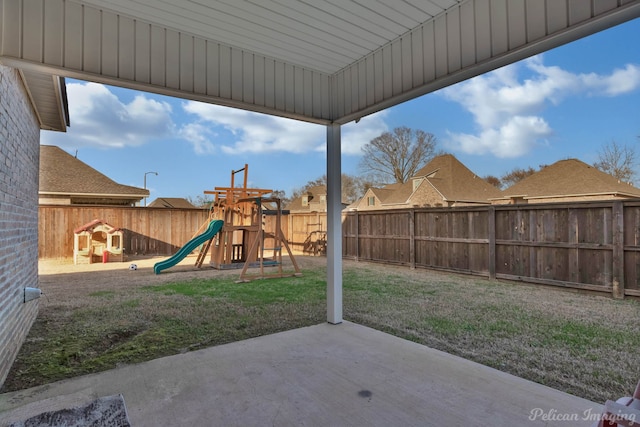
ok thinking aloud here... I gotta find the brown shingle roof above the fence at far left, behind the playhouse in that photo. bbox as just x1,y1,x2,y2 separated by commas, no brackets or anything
40,145,149,199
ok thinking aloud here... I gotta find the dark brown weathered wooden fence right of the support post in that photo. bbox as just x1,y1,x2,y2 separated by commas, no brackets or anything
343,200,640,298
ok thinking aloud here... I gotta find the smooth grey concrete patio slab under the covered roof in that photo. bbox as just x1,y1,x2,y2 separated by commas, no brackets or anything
0,322,602,427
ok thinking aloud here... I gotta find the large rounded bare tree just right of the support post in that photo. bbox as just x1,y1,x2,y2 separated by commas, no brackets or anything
359,127,437,183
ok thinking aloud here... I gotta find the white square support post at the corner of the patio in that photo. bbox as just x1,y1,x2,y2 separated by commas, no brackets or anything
327,124,342,325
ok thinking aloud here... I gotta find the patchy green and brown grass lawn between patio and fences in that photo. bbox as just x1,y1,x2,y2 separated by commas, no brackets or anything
2,262,640,402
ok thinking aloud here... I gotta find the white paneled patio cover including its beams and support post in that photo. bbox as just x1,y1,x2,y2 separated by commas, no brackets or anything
0,0,640,323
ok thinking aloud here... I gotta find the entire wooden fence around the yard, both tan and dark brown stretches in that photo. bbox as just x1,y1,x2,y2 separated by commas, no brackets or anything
38,200,640,298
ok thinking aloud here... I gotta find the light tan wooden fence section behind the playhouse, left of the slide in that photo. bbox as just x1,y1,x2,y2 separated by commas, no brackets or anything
38,205,208,258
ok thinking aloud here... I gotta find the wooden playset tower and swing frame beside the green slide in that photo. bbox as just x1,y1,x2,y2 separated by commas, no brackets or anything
196,164,300,281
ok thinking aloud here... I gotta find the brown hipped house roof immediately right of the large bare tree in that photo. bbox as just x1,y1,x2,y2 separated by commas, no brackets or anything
414,154,502,203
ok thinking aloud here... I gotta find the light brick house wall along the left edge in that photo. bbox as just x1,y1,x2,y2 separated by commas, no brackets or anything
0,65,40,385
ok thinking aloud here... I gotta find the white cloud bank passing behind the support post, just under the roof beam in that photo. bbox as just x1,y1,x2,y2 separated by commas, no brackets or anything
181,101,386,155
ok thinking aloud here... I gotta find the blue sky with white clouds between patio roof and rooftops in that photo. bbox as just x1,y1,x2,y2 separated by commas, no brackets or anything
41,19,640,202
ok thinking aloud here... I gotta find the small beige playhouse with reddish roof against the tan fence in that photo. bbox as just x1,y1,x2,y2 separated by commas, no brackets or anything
73,219,124,264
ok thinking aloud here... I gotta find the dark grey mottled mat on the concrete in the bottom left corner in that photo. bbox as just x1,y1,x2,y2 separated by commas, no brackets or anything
9,394,131,427
